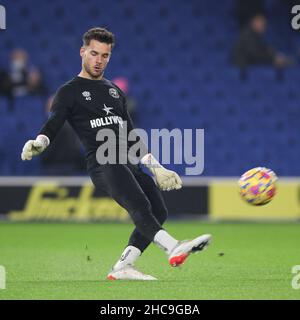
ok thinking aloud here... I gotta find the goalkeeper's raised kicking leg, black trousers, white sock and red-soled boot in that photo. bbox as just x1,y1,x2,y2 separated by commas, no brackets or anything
90,165,210,280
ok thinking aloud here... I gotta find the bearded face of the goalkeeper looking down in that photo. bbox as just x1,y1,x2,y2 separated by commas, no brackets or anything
80,40,111,79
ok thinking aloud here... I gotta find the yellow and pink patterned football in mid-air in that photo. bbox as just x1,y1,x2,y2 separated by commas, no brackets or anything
238,167,277,206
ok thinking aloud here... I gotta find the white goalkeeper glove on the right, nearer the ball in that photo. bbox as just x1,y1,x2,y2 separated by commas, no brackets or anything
141,153,182,191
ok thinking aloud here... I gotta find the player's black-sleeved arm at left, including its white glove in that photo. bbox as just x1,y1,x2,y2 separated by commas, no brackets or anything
21,87,73,161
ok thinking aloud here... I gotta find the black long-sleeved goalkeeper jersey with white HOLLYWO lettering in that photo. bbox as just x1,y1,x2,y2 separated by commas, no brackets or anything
40,77,133,169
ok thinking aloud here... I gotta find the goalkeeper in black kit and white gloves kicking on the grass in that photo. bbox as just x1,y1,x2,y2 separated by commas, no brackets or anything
21,28,211,280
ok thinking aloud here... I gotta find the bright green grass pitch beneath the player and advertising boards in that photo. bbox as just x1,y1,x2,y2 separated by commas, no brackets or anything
0,221,300,300
